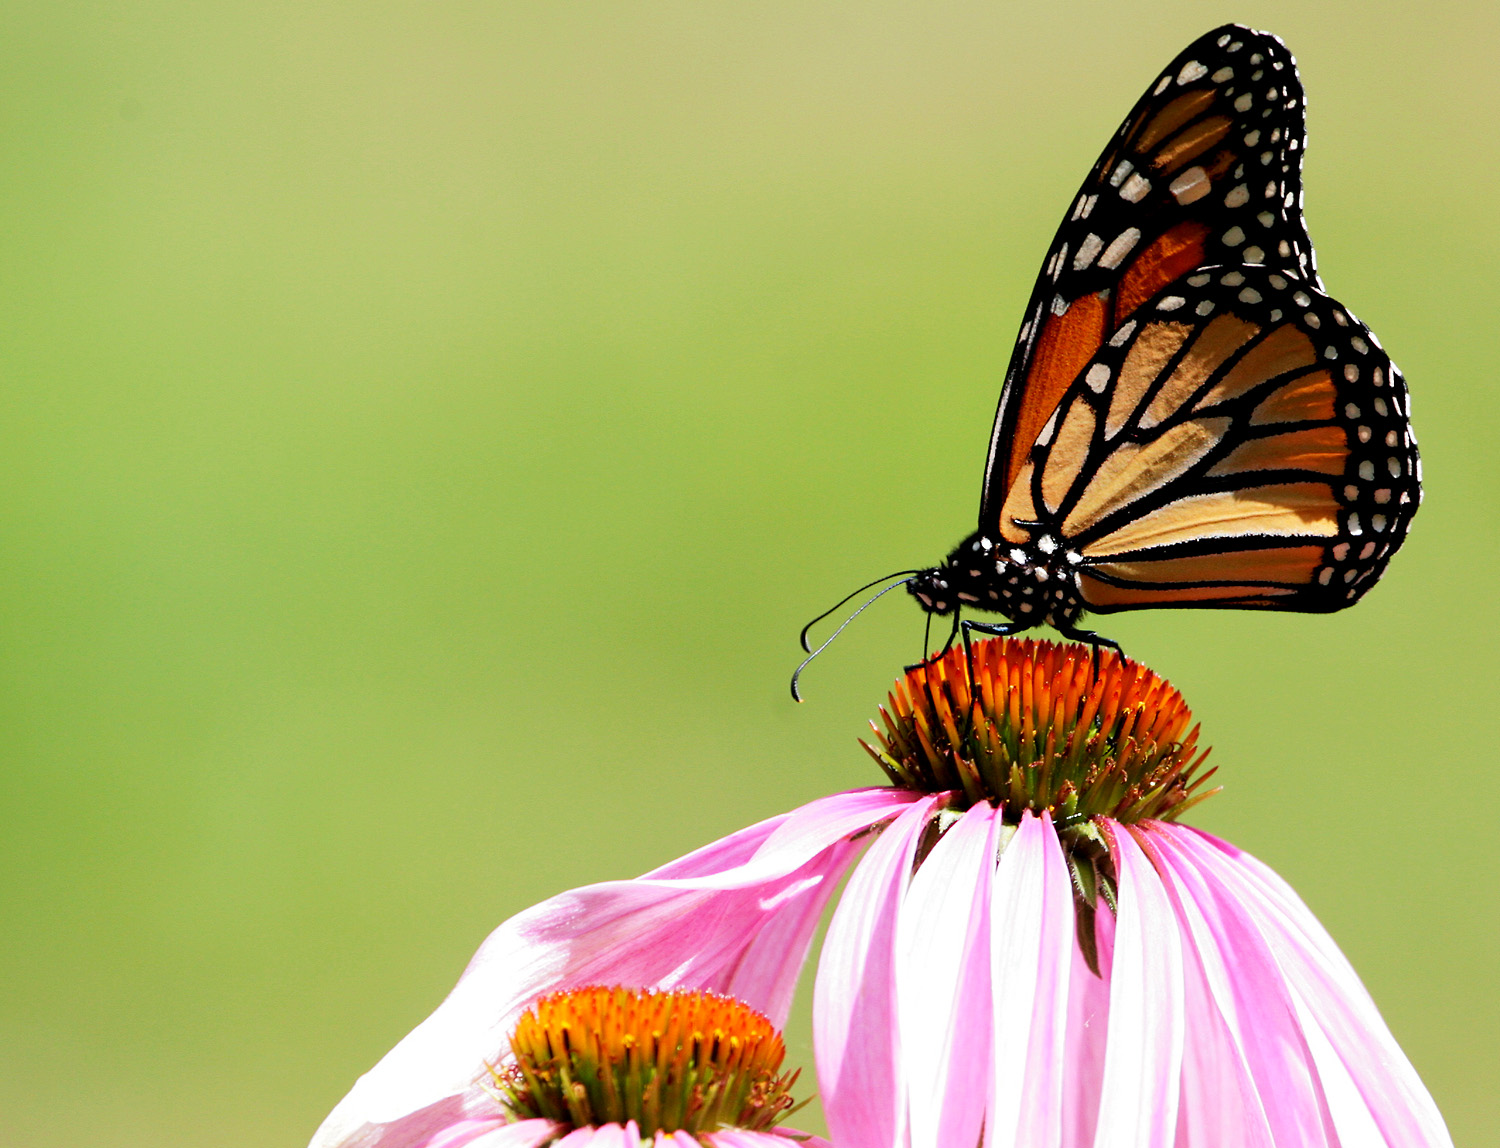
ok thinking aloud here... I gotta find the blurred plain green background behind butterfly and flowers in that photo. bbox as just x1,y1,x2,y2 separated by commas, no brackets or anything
0,0,1500,1148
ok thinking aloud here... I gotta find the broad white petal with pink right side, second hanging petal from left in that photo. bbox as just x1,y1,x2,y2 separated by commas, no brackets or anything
896,803,1001,1148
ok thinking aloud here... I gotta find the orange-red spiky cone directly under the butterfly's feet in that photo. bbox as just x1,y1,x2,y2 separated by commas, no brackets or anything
860,638,1217,827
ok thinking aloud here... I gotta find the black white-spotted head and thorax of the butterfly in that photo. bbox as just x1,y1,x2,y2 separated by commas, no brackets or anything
906,533,1083,629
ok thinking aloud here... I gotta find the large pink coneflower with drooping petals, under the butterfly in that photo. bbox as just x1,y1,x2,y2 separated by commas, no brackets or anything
314,639,1451,1148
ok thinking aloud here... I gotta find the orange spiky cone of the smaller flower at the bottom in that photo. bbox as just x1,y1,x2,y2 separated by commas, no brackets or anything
495,986,797,1137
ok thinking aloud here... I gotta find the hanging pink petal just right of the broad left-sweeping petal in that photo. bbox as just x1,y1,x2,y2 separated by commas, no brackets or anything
813,797,939,1148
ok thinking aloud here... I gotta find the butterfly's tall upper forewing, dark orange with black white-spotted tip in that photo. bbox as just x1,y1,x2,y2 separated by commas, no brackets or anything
980,26,1317,522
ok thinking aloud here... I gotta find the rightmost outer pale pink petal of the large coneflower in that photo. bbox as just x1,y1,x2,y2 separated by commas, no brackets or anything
1176,830,1452,1148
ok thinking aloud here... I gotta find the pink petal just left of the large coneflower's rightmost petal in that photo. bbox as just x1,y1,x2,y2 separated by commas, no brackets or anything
1149,824,1337,1148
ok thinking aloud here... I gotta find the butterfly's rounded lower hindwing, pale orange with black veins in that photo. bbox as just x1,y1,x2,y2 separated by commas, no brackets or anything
987,266,1421,612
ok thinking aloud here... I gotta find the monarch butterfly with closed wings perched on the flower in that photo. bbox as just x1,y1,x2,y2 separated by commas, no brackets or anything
792,24,1421,696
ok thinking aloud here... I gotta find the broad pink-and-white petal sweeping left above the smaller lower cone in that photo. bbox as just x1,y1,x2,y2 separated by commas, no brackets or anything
312,788,917,1148
